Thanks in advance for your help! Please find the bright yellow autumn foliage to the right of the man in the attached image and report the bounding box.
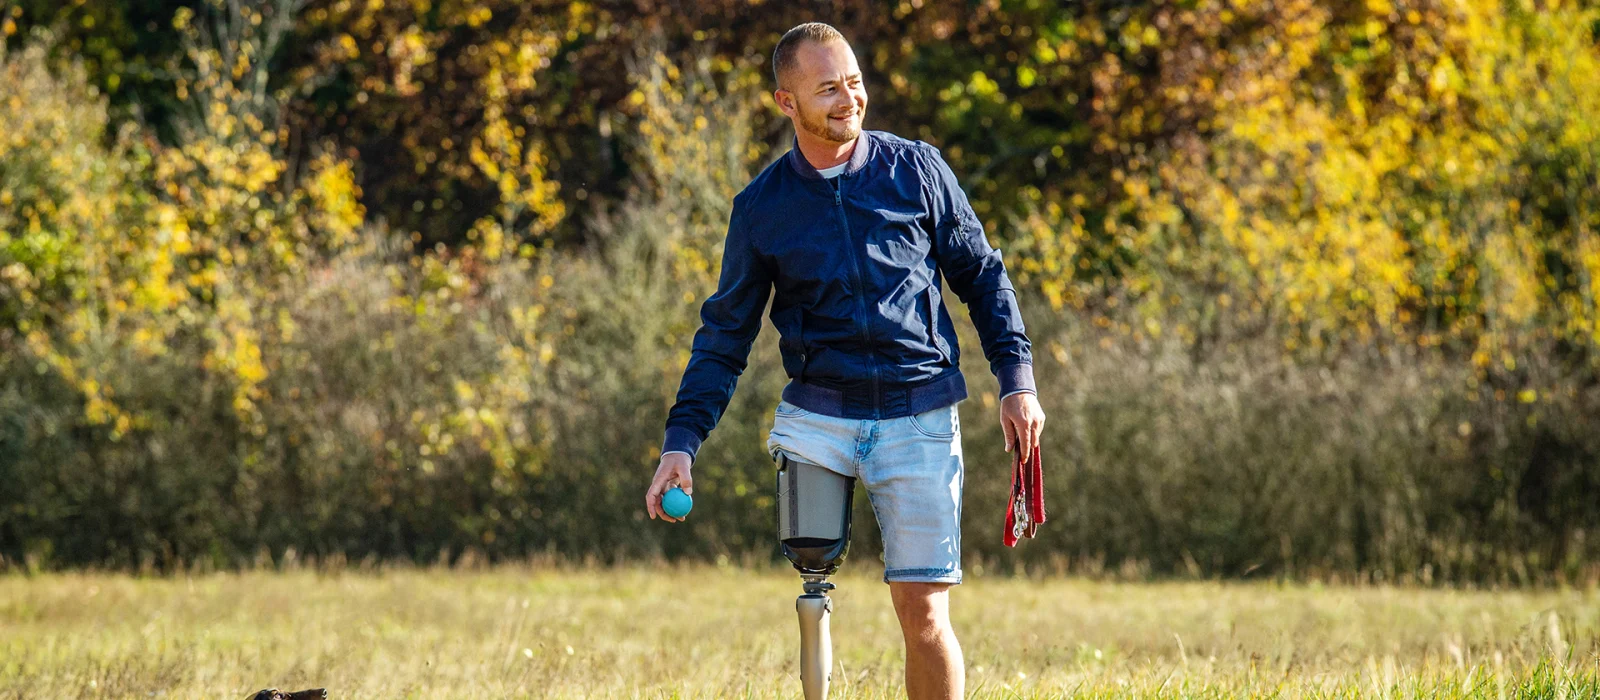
[1014,0,1600,368]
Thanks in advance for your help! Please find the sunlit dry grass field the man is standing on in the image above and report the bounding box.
[0,561,1600,698]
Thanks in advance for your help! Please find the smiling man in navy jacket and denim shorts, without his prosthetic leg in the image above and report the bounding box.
[645,22,1045,698]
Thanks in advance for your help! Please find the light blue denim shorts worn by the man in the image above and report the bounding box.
[766,401,965,583]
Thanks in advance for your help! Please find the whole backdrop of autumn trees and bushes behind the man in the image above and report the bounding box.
[0,0,1600,583]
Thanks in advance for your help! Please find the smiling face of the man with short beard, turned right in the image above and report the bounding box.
[773,42,867,144]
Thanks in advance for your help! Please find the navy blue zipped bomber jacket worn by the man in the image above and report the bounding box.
[661,131,1034,460]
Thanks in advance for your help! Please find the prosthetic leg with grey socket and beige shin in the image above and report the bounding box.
[778,452,856,700]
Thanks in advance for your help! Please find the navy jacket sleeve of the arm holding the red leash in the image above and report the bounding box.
[920,144,1038,398]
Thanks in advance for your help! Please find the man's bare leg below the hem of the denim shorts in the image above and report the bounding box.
[890,582,966,700]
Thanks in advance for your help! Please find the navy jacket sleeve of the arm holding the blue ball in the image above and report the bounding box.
[661,203,773,462]
